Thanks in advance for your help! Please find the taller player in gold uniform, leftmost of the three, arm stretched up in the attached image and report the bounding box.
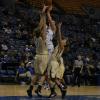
[27,6,48,97]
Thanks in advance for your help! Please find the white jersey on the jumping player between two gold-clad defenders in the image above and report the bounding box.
[46,28,54,55]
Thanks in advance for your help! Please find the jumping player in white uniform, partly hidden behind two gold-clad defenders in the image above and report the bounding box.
[34,5,56,94]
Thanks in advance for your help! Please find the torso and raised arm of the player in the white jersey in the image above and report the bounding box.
[46,6,56,56]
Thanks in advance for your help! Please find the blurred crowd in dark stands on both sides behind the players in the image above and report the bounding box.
[0,1,100,86]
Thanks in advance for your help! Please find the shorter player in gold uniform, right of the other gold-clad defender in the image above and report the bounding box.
[48,23,67,98]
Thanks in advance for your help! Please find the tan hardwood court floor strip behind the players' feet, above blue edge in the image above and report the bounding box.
[0,85,100,96]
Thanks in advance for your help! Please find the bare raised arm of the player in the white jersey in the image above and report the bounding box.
[47,6,56,33]
